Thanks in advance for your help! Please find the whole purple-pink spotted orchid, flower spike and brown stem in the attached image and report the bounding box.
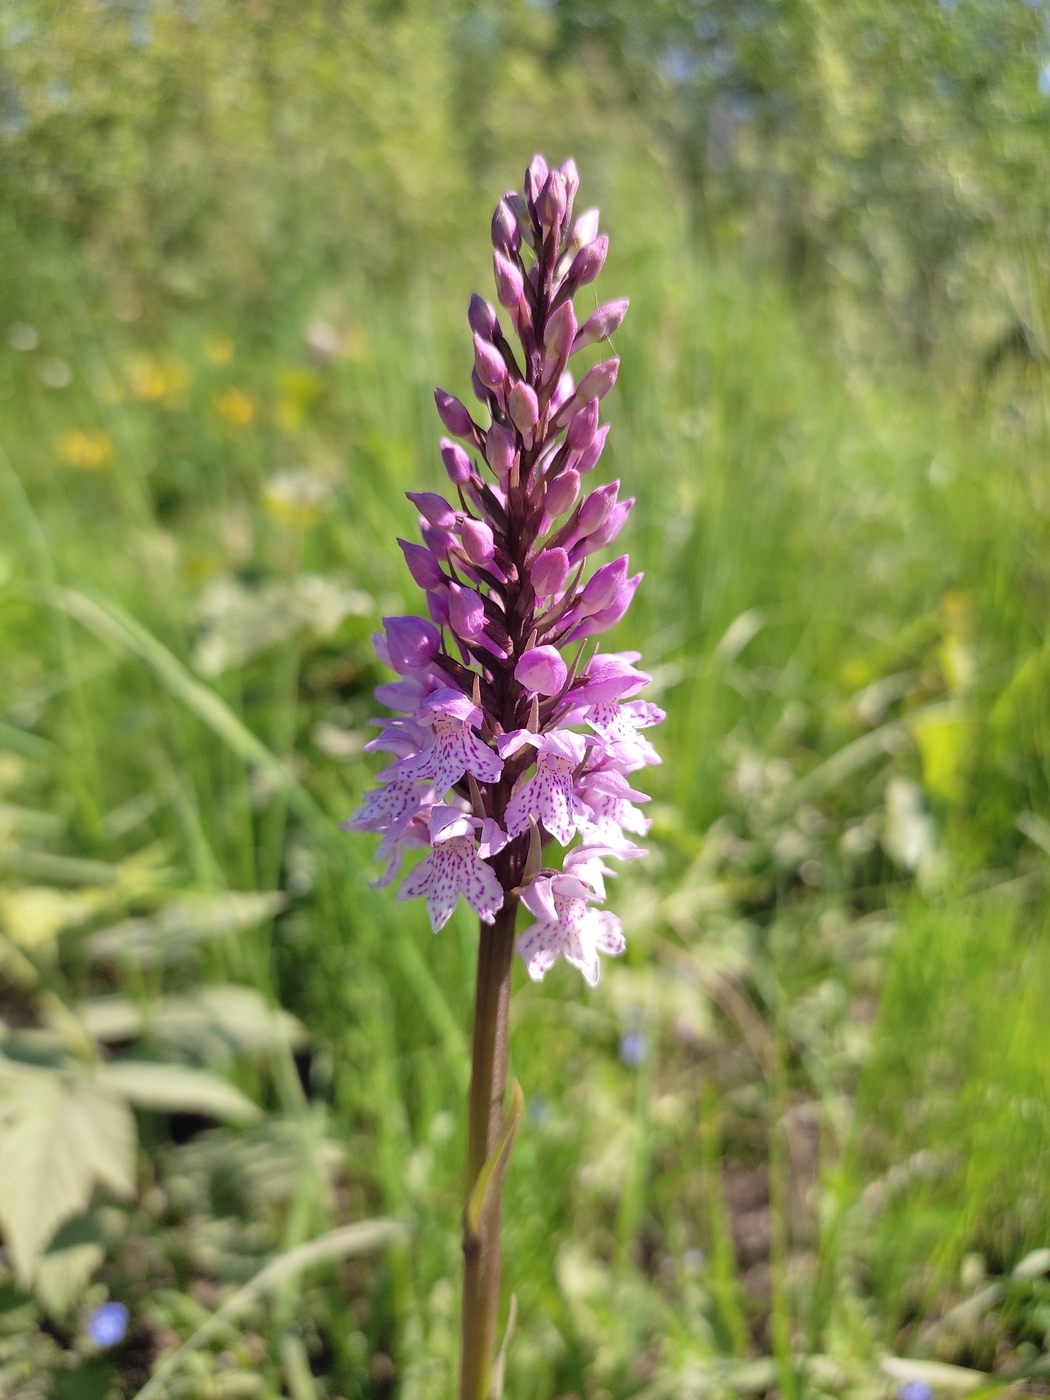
[344,155,662,1400]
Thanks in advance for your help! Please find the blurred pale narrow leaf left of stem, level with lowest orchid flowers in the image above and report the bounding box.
[87,893,284,967]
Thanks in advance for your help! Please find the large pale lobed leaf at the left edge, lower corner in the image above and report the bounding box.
[0,1063,136,1287]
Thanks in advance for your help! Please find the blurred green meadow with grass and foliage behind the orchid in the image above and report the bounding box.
[0,0,1050,1400]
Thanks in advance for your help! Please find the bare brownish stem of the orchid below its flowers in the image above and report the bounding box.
[459,896,518,1400]
